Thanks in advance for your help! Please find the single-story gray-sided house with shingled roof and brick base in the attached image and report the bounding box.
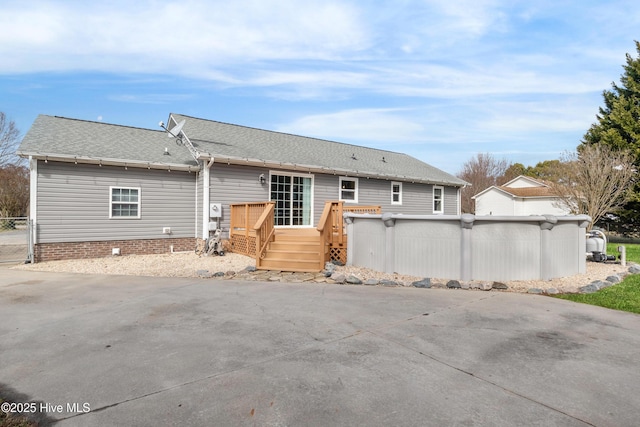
[18,114,466,261]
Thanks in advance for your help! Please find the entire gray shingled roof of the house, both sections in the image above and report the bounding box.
[18,114,466,186]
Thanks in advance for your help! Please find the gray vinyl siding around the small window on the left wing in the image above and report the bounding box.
[36,161,196,243]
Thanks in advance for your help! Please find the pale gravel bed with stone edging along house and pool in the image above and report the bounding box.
[12,252,629,294]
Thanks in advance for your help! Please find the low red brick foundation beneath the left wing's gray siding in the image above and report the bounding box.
[34,237,196,262]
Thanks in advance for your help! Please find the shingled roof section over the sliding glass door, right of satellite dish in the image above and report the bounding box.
[172,114,466,186]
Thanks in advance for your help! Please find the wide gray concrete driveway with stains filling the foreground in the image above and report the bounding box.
[0,267,640,426]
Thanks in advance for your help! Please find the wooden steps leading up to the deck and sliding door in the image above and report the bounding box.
[256,228,324,272]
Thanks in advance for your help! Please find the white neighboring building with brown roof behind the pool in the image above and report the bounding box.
[472,175,570,216]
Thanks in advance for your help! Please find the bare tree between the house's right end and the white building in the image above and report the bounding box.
[457,153,510,213]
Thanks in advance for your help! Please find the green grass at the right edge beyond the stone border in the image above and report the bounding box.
[554,243,640,314]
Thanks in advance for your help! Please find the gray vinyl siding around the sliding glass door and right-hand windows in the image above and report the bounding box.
[208,163,458,234]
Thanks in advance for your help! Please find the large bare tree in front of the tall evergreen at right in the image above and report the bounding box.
[552,144,637,231]
